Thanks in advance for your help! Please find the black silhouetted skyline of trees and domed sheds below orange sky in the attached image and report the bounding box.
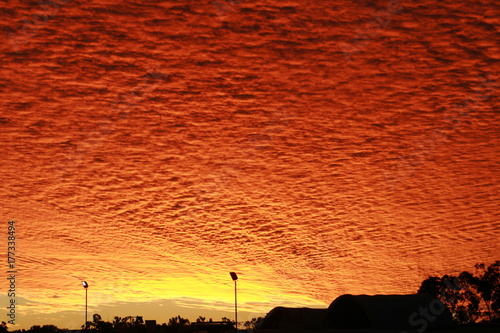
[5,261,500,333]
